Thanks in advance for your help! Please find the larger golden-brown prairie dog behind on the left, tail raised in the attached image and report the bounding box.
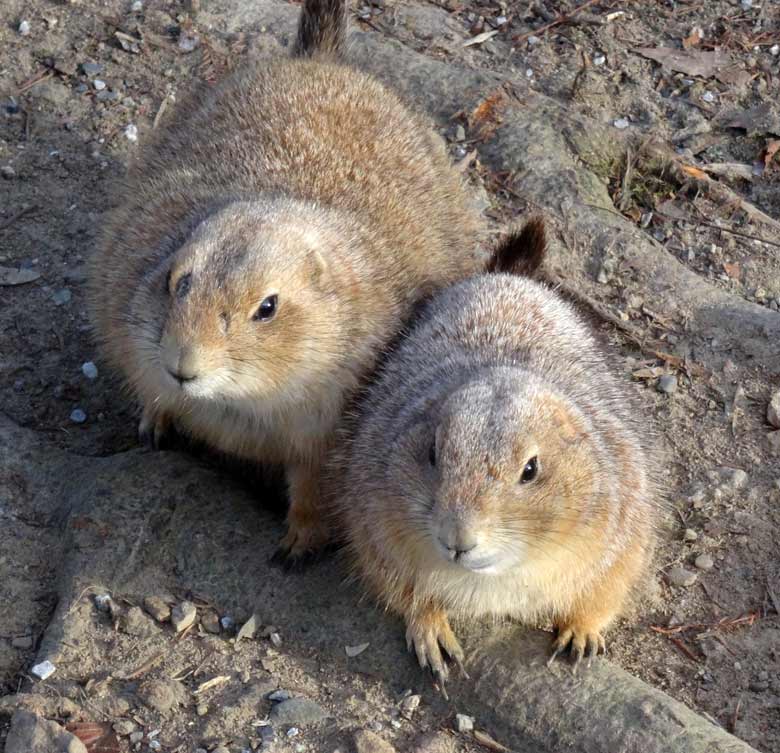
[90,0,481,555]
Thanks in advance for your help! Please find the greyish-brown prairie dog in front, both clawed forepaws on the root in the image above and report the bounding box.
[331,221,660,681]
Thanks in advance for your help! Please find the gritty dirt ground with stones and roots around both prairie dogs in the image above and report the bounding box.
[0,0,780,753]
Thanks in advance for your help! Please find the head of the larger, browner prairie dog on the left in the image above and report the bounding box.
[132,202,354,404]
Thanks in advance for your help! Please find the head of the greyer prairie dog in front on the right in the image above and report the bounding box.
[401,370,601,576]
